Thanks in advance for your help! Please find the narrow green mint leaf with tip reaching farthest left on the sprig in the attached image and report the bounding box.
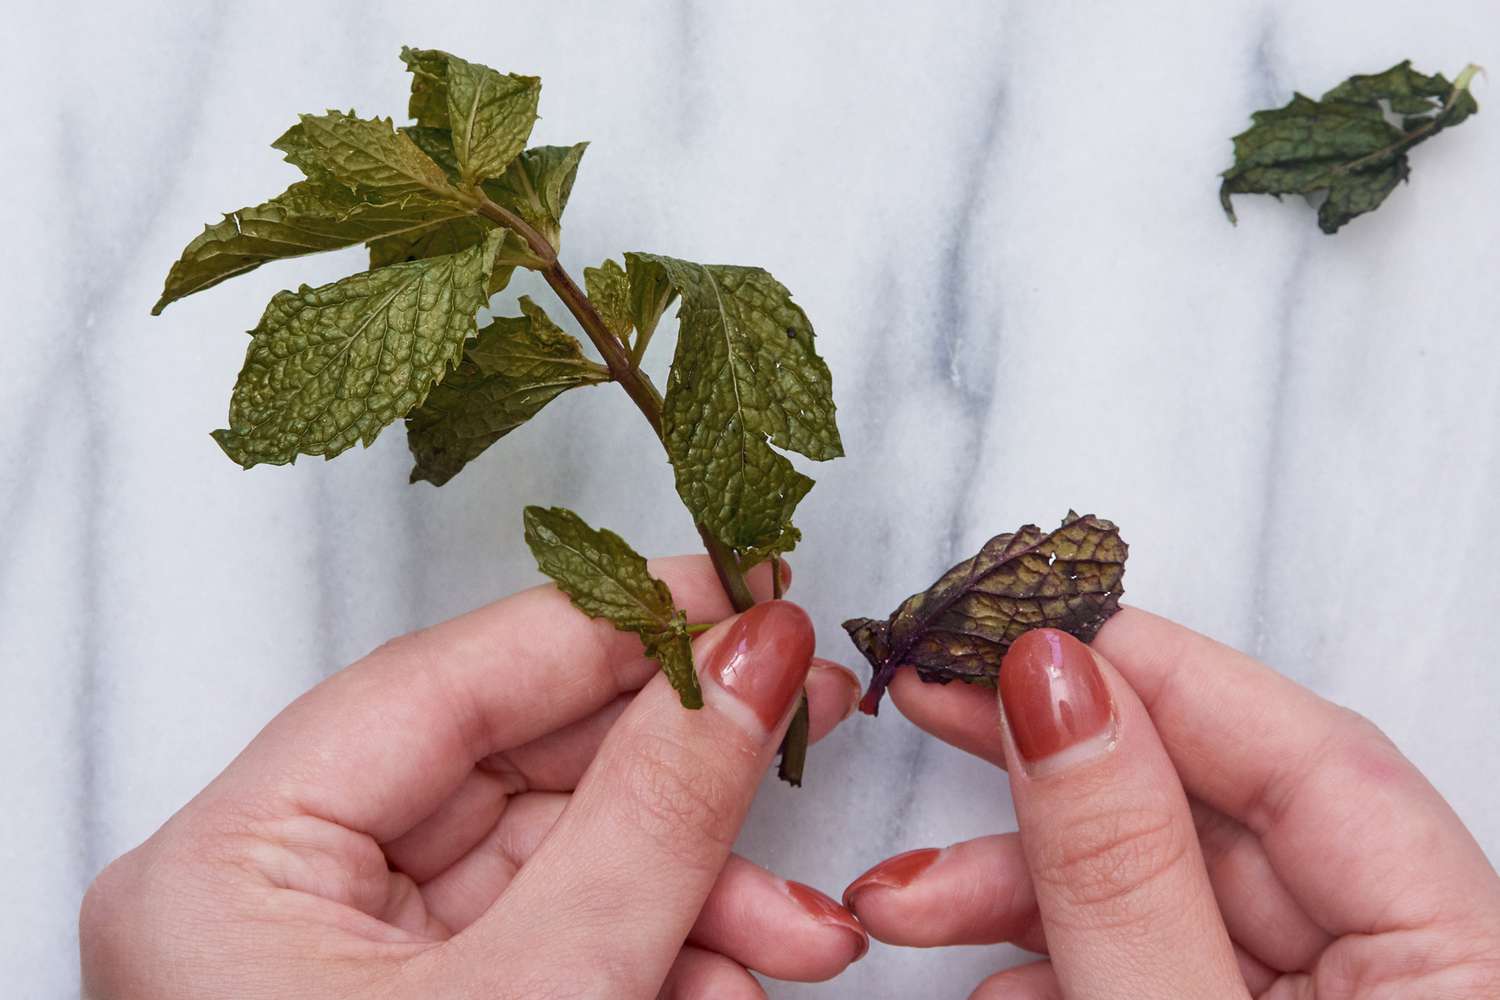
[152,173,467,315]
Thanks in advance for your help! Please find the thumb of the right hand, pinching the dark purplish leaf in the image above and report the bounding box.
[999,628,1248,1000]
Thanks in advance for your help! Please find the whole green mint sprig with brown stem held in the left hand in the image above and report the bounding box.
[153,48,843,784]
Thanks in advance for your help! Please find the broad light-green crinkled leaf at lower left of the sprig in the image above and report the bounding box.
[213,237,500,468]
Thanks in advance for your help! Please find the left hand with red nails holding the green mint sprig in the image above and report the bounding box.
[80,558,867,1000]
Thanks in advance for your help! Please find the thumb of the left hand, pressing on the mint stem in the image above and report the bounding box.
[465,601,815,997]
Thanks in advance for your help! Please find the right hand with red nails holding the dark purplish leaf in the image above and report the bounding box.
[845,609,1500,1000]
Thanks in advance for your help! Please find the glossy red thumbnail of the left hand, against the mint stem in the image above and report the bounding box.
[704,601,815,732]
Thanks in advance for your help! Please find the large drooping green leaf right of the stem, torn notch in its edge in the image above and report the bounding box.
[626,253,843,552]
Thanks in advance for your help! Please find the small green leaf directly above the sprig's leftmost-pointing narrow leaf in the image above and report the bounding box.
[275,111,459,208]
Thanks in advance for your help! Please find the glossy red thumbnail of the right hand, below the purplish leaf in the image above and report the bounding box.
[1001,628,1115,775]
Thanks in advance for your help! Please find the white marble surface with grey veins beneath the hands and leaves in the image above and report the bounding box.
[0,0,1500,997]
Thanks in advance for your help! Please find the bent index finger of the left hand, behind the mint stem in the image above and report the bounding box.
[201,556,771,841]
